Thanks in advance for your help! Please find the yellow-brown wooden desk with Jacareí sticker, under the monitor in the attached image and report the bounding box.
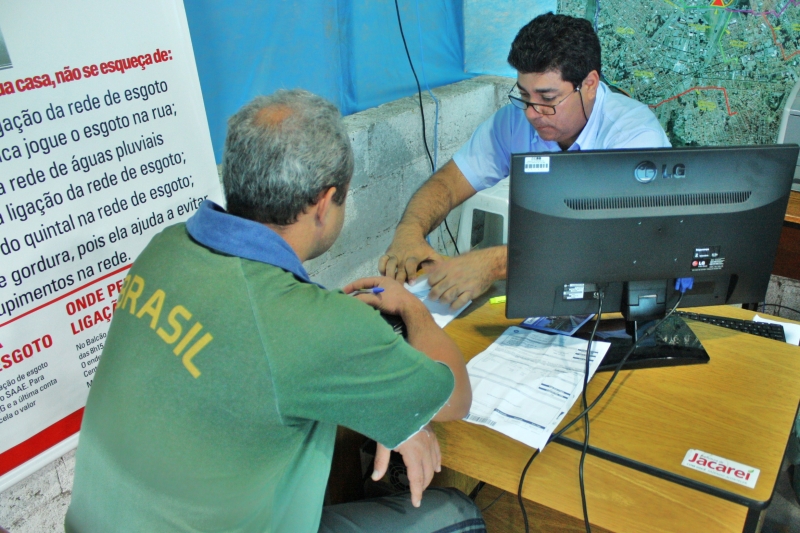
[436,303,800,532]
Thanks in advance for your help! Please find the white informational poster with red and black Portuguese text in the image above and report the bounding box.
[0,0,222,490]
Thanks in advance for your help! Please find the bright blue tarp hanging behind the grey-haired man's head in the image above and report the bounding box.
[185,0,471,161]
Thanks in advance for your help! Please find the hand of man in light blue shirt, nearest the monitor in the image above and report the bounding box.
[425,246,506,309]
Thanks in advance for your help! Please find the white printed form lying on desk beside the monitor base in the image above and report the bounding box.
[464,327,610,450]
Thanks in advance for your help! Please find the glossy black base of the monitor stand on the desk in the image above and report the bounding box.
[575,315,709,372]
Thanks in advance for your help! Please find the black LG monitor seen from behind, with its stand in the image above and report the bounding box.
[506,145,800,367]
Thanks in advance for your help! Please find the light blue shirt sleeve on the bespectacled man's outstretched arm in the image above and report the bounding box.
[453,105,522,191]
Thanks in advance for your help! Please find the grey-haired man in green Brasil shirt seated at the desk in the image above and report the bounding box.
[66,90,484,533]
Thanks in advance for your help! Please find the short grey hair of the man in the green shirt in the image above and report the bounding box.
[222,89,353,226]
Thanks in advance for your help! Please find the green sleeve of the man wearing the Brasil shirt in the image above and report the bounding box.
[270,285,455,448]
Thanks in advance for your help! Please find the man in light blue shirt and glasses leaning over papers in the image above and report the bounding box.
[378,13,670,309]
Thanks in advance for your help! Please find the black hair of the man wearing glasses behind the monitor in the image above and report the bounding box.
[508,13,600,87]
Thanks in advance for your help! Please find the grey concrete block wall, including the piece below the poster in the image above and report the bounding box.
[0,76,513,533]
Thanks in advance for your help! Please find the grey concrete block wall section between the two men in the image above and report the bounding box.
[306,76,514,288]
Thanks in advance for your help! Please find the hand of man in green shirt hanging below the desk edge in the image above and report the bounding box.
[372,424,442,507]
